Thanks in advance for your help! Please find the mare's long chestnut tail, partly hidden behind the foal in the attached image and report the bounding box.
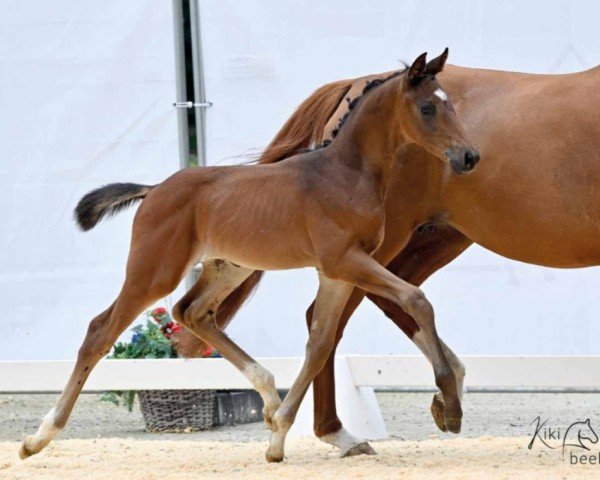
[176,80,355,357]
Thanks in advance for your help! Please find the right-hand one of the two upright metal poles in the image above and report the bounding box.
[190,0,210,167]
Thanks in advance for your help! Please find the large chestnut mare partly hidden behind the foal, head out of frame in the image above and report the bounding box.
[180,59,600,455]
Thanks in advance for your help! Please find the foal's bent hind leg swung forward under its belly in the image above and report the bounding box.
[173,260,281,428]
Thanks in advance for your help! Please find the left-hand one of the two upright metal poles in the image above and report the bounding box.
[173,0,190,168]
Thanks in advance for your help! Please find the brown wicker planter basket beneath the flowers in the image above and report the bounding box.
[138,390,216,432]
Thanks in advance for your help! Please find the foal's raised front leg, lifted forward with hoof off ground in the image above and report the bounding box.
[326,250,462,433]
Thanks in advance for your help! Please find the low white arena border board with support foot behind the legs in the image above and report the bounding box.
[0,355,600,439]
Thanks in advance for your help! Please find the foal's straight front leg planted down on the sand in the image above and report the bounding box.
[266,272,354,462]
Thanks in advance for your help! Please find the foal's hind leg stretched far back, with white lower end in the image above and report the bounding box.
[19,228,189,459]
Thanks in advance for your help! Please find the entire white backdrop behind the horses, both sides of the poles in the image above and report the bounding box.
[0,0,600,360]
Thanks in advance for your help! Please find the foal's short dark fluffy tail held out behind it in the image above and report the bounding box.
[73,183,154,232]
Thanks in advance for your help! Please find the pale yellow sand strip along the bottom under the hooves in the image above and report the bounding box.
[0,437,600,480]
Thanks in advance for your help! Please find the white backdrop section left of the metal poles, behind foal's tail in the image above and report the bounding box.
[0,0,179,360]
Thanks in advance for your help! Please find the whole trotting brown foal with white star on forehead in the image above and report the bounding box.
[20,49,479,461]
